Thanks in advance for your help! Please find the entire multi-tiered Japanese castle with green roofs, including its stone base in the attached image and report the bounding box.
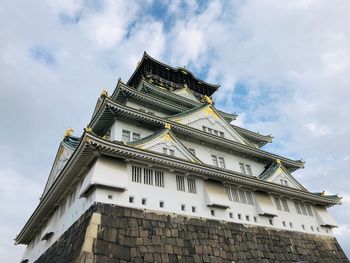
[15,53,348,263]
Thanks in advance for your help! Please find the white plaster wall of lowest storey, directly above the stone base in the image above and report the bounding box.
[23,158,332,262]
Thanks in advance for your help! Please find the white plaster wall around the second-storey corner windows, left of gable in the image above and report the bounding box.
[110,120,156,141]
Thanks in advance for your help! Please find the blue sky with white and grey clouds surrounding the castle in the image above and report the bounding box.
[0,0,350,262]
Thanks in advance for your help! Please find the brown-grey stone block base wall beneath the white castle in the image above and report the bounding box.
[37,204,349,263]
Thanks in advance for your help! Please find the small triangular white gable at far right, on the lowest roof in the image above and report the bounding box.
[259,159,307,191]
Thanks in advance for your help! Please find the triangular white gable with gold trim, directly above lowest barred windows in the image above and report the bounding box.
[128,124,202,163]
